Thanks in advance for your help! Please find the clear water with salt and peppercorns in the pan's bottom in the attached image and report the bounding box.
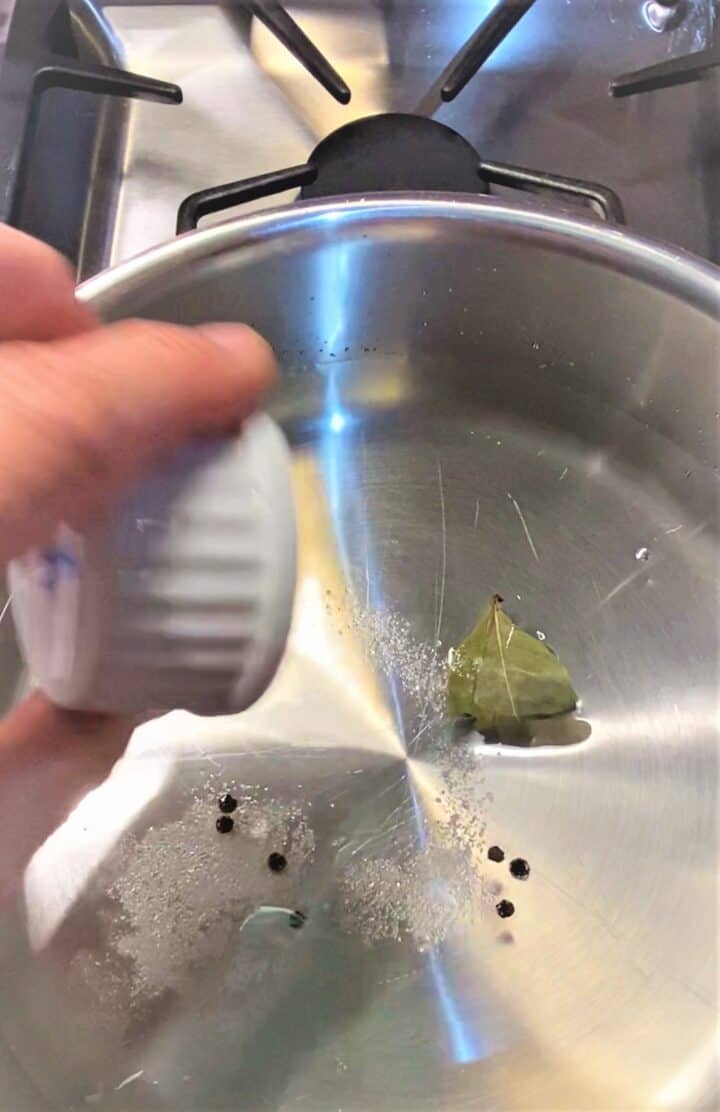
[2,358,717,1112]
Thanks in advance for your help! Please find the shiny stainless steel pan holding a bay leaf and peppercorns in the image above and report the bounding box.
[0,196,720,1112]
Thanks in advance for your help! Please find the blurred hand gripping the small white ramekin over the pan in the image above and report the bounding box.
[0,226,274,907]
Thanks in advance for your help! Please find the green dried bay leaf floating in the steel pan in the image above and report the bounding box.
[447,595,578,733]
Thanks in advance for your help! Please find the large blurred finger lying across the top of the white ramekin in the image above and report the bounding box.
[0,320,275,563]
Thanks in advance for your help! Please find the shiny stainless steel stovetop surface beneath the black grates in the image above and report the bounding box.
[0,0,720,277]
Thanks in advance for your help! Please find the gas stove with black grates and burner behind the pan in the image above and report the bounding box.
[0,0,720,277]
